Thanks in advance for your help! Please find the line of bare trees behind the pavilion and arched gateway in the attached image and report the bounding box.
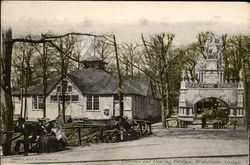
[1,30,250,155]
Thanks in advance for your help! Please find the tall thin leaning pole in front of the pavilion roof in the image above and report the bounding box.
[113,35,123,117]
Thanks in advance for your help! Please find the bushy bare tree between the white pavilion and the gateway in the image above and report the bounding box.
[141,33,178,127]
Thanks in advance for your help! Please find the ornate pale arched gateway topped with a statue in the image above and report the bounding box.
[178,33,244,121]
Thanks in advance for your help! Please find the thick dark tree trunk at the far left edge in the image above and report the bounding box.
[1,29,13,155]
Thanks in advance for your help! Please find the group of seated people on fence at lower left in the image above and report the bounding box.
[14,118,68,156]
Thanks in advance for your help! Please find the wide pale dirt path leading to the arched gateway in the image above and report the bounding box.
[2,124,249,165]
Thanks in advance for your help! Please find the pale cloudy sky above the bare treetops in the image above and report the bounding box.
[1,1,250,45]
